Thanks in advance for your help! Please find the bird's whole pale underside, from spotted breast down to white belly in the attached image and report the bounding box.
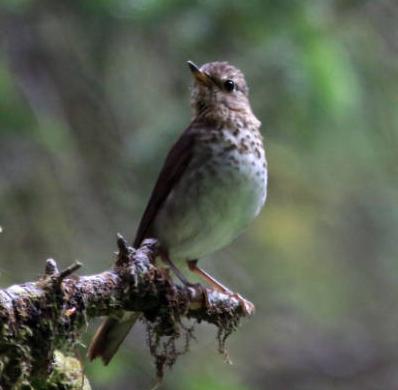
[156,123,267,259]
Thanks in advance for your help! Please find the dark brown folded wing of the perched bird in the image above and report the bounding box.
[133,128,195,248]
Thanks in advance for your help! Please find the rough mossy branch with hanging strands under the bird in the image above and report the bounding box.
[0,236,250,389]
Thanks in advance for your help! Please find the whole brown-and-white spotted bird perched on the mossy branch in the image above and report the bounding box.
[88,61,268,365]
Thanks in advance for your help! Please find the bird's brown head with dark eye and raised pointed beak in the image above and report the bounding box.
[188,61,251,117]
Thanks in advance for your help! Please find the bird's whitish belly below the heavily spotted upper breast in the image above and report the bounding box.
[155,154,267,259]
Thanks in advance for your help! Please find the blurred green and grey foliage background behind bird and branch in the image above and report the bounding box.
[0,0,398,390]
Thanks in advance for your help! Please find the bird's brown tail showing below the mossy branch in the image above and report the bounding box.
[87,312,140,365]
